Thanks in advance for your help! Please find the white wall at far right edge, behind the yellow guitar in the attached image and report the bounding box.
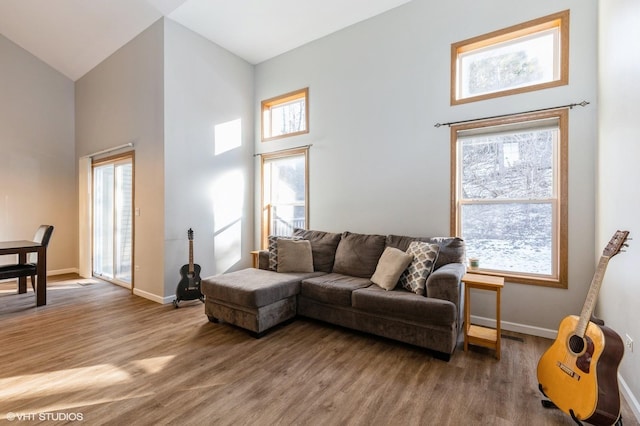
[596,0,640,419]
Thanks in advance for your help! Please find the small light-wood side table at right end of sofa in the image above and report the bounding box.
[462,274,504,359]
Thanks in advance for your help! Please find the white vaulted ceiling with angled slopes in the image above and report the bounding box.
[0,0,410,81]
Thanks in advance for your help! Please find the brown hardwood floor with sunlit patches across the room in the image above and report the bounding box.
[0,277,638,426]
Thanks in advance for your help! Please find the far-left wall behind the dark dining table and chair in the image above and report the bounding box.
[0,35,78,273]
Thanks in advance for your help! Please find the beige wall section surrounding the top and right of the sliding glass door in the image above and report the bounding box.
[74,21,164,301]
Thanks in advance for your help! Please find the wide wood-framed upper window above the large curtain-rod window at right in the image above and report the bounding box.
[451,10,569,105]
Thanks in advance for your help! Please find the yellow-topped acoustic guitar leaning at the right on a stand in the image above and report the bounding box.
[538,231,629,425]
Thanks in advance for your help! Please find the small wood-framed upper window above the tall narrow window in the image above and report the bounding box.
[262,88,309,142]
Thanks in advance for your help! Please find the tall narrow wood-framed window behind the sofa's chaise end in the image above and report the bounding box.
[261,148,309,247]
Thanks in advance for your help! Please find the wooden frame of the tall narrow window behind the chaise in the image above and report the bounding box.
[260,146,309,249]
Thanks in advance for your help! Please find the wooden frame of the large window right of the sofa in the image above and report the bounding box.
[450,108,569,288]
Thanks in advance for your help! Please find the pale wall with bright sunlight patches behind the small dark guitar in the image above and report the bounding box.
[164,19,254,300]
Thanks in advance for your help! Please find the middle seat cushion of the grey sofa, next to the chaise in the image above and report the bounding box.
[300,273,371,306]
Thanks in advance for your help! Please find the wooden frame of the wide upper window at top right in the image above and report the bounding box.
[451,10,570,105]
